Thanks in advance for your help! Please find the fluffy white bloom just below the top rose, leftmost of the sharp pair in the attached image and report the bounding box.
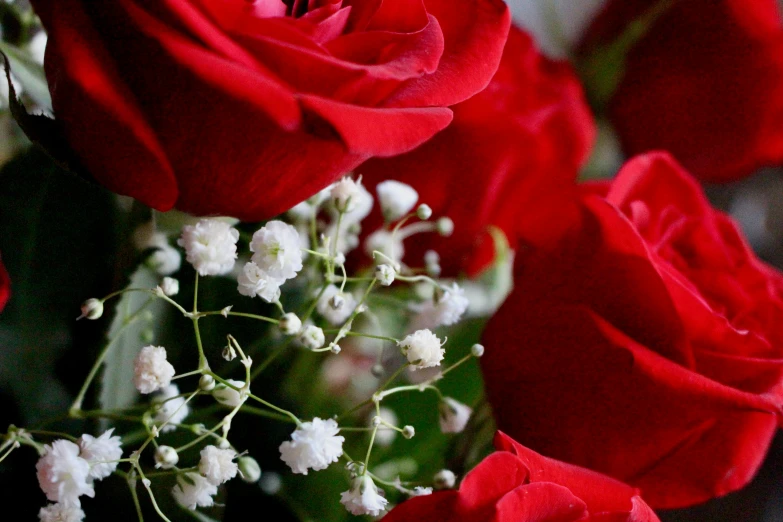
[177,219,239,276]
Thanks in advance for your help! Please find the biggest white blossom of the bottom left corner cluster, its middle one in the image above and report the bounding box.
[35,439,95,508]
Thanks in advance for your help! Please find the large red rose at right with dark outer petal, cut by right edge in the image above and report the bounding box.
[481,153,783,508]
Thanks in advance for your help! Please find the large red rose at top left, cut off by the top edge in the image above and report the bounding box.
[32,0,510,220]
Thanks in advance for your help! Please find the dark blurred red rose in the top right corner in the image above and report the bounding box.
[582,0,783,181]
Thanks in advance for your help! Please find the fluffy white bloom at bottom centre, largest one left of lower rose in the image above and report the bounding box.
[280,417,345,475]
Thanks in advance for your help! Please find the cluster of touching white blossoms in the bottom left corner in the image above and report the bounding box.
[35,430,122,522]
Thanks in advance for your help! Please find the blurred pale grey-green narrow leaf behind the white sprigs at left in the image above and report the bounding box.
[98,266,169,416]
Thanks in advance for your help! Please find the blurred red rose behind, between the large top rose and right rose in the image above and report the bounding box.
[356,23,595,275]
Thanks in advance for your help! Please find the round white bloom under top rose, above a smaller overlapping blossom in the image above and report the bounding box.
[250,221,302,279]
